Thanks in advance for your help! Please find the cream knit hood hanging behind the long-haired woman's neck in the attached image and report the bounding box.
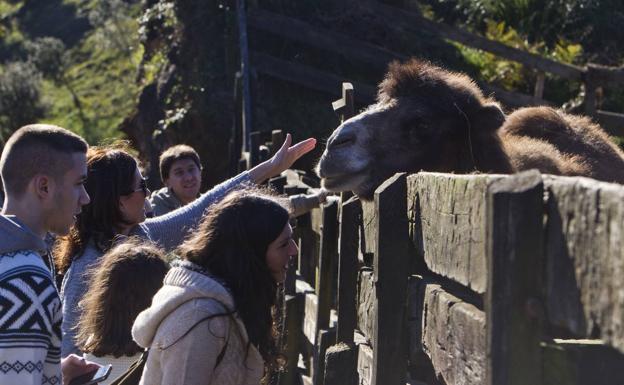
[132,261,239,347]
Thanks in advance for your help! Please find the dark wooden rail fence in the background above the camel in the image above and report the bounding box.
[237,0,624,138]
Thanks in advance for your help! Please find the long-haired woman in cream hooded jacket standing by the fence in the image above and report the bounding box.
[132,189,297,385]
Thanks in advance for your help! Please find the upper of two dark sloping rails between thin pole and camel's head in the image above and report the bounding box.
[247,9,406,70]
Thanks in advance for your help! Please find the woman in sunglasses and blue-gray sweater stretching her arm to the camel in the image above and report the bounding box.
[54,134,316,357]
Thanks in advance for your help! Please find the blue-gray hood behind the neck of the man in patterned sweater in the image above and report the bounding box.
[0,215,48,255]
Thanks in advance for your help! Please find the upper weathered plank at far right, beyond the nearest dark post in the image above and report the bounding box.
[545,177,624,352]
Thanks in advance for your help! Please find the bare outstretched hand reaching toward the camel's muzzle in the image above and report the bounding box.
[249,134,316,184]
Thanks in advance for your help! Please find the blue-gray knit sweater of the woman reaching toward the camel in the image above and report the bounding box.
[61,172,250,357]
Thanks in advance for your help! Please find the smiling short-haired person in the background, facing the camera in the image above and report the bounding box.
[149,144,202,216]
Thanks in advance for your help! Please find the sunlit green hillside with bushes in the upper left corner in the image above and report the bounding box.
[0,0,142,143]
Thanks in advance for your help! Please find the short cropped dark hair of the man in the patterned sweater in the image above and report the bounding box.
[0,124,89,197]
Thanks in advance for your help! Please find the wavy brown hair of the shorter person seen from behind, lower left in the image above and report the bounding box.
[76,238,169,357]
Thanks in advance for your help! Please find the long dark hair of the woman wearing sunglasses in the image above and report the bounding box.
[54,144,137,273]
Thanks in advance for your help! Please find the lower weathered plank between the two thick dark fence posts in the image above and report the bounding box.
[408,277,486,385]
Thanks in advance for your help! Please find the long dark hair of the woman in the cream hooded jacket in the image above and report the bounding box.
[179,188,288,372]
